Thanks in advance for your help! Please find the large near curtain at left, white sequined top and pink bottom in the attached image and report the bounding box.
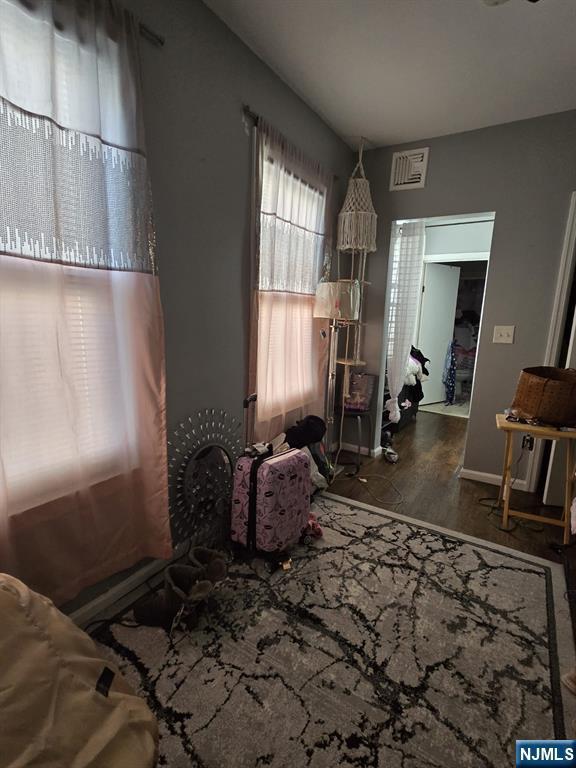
[0,0,172,603]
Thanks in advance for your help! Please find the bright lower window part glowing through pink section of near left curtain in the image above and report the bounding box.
[0,258,134,514]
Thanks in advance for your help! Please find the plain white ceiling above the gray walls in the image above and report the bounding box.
[205,0,576,146]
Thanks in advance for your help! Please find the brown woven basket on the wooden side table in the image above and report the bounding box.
[511,366,576,427]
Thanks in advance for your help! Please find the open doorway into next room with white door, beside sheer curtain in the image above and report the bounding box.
[383,212,495,447]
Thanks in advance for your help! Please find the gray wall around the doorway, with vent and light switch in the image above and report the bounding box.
[365,111,576,477]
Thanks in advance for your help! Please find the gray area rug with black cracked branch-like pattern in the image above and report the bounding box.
[98,496,564,768]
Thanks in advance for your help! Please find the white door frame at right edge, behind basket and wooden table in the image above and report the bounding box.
[526,191,576,491]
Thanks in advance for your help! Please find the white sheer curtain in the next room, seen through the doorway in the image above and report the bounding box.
[384,221,426,422]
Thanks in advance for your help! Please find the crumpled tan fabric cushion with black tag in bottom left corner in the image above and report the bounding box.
[0,574,158,768]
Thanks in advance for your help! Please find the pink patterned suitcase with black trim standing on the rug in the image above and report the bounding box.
[231,448,311,552]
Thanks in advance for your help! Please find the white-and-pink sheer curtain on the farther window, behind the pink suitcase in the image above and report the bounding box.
[252,123,330,440]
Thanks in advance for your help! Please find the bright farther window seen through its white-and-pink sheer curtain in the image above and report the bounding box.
[257,158,326,421]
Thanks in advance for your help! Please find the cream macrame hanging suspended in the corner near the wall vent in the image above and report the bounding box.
[337,142,378,253]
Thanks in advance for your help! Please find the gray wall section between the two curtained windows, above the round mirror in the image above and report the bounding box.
[122,0,352,427]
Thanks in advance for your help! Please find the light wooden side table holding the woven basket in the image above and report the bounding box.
[496,413,576,544]
